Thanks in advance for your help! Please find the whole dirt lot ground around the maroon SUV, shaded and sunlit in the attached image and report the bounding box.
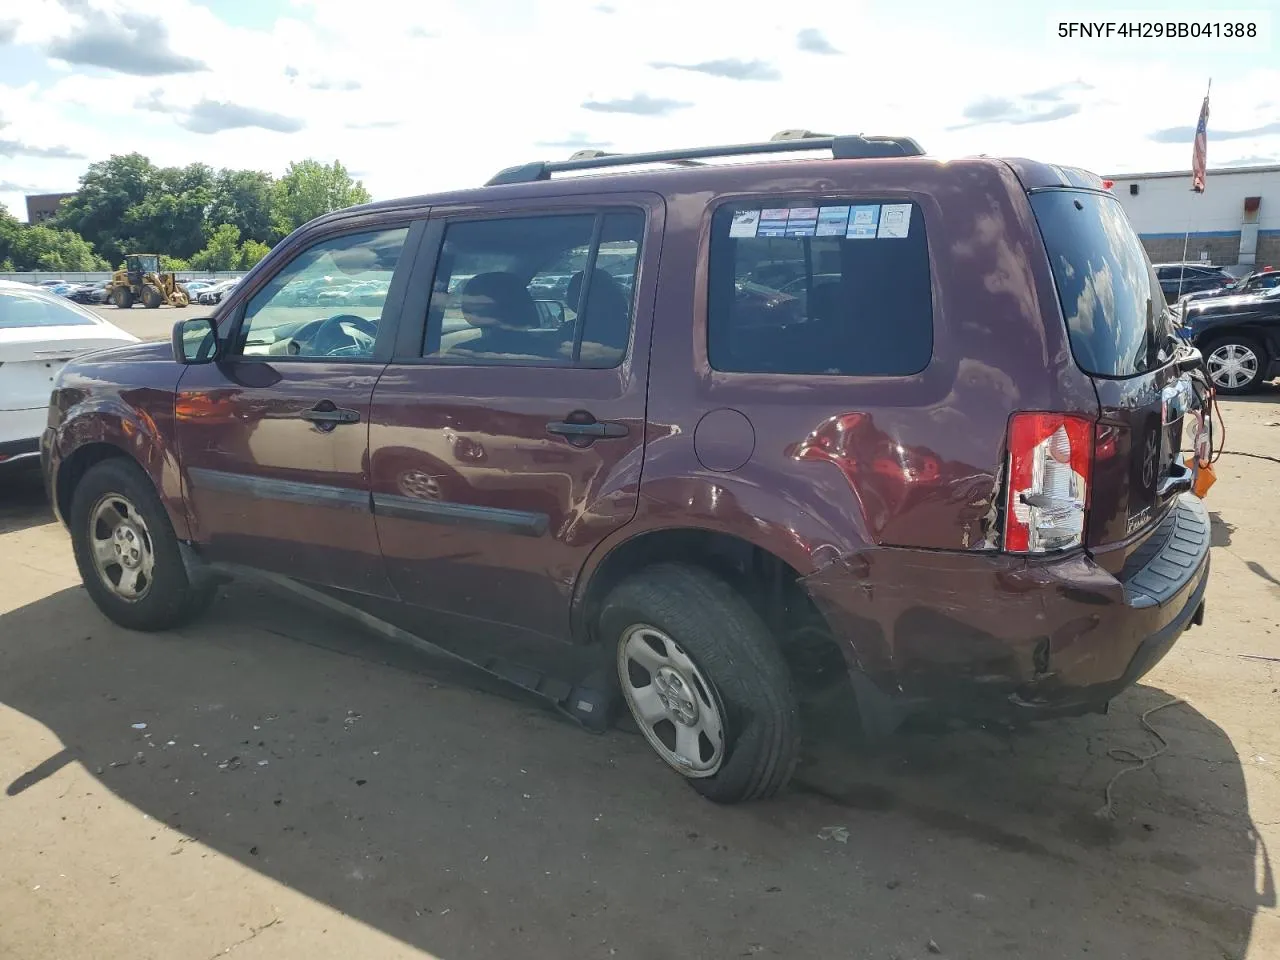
[0,391,1280,960]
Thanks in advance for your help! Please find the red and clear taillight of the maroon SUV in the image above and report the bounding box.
[1005,413,1094,553]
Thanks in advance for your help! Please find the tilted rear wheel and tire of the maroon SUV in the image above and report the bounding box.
[599,563,800,804]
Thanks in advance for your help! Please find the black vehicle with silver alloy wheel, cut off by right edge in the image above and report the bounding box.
[1178,284,1280,394]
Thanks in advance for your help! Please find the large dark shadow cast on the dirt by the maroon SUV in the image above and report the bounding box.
[0,584,1259,960]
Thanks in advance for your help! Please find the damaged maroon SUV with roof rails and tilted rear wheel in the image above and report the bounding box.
[42,129,1210,801]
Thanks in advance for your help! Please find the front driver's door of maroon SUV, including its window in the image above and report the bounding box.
[175,225,421,596]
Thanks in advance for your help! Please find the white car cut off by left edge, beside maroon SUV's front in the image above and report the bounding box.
[0,280,138,468]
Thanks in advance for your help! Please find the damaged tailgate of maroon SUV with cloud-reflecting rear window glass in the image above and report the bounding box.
[1030,188,1202,562]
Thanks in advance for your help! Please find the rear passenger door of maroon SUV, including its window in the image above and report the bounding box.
[370,202,662,639]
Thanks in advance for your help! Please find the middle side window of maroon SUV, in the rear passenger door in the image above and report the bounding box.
[422,211,644,369]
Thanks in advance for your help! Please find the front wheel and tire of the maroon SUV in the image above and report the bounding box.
[69,457,216,631]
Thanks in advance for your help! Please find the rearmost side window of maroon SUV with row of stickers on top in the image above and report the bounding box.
[707,200,933,376]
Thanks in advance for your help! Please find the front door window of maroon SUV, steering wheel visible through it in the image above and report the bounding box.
[238,227,408,360]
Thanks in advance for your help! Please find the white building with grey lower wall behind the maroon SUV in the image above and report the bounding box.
[1106,165,1280,273]
